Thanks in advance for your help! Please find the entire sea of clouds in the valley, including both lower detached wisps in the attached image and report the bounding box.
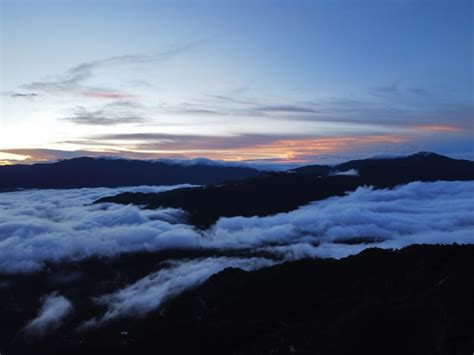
[0,181,474,335]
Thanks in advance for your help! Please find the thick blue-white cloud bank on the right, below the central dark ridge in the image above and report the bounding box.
[207,181,474,257]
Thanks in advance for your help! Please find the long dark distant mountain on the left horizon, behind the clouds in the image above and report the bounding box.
[0,158,261,190]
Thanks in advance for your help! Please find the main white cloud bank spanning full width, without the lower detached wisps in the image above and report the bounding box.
[0,181,474,273]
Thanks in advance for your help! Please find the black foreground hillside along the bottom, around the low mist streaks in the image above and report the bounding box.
[0,245,474,355]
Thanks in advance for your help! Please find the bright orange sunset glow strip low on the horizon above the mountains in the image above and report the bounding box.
[0,134,408,163]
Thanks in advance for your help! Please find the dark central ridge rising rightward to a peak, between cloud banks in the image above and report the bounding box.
[97,153,474,228]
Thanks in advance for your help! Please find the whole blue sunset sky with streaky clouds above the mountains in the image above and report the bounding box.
[0,0,474,164]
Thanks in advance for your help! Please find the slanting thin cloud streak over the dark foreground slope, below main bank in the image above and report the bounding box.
[82,257,275,328]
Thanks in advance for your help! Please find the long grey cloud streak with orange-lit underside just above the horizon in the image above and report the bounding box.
[0,133,413,163]
